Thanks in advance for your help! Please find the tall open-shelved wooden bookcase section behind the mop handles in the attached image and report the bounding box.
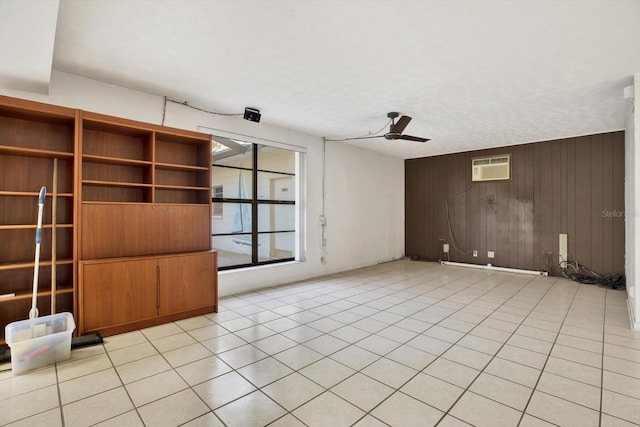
[0,96,76,344]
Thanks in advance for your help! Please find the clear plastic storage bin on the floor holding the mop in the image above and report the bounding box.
[5,313,76,374]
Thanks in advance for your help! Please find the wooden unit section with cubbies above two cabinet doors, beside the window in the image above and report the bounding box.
[79,113,217,334]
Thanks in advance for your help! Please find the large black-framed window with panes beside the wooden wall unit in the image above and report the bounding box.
[211,136,299,270]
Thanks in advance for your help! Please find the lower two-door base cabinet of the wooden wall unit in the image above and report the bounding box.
[78,251,218,335]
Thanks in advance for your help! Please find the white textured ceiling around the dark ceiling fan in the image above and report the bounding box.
[47,0,640,158]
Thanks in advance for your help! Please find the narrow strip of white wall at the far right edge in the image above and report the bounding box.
[625,74,640,330]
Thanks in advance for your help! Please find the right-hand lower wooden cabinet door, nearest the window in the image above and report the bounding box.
[158,252,217,315]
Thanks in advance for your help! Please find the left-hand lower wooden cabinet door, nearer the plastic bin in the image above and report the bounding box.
[80,258,158,330]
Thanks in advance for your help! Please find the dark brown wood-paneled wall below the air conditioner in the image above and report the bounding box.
[405,132,624,275]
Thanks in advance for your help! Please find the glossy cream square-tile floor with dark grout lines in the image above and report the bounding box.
[0,260,640,427]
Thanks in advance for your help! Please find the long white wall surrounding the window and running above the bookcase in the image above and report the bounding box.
[0,71,404,296]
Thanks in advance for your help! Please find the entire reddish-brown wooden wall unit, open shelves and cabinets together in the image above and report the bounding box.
[0,97,217,344]
